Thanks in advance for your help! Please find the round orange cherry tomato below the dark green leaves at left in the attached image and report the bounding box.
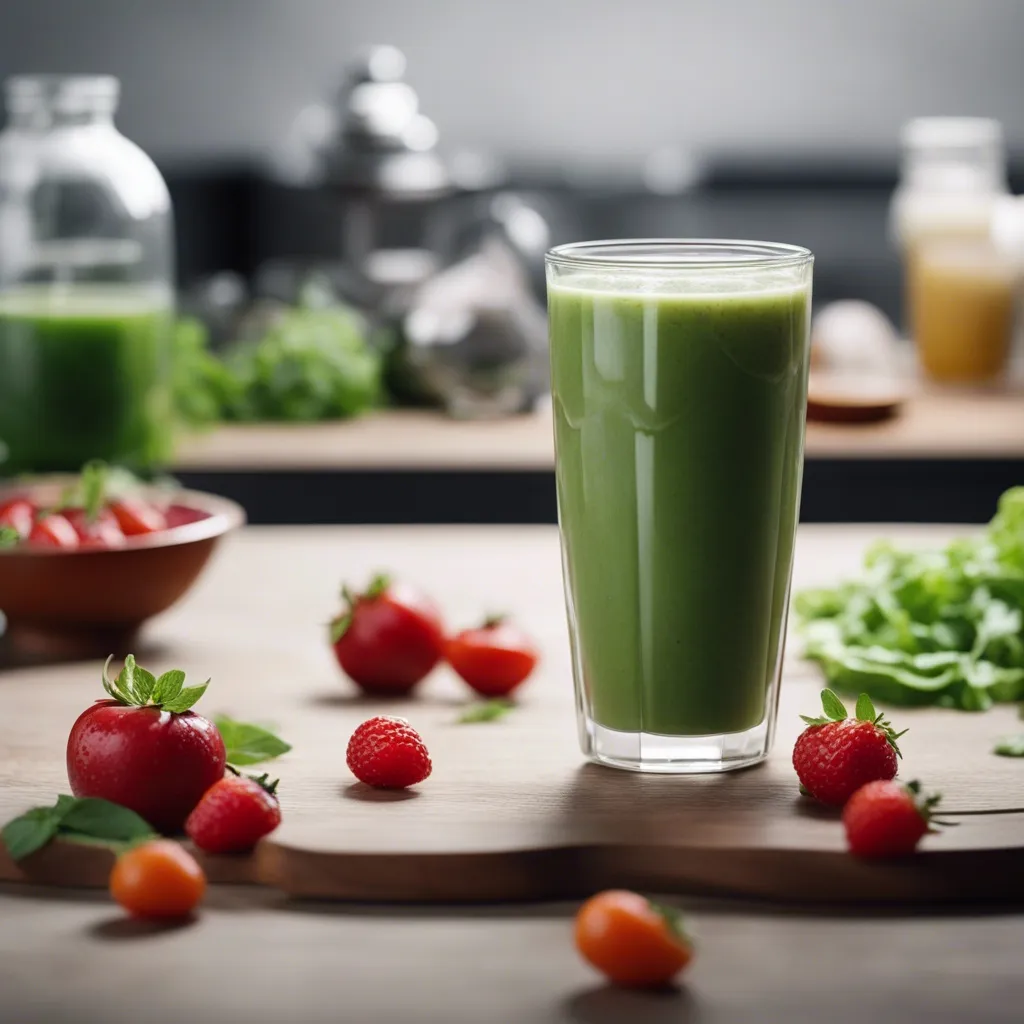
[110,839,206,919]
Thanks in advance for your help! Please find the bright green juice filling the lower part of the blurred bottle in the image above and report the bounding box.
[0,288,171,474]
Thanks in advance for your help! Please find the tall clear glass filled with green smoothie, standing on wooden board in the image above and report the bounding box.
[547,240,813,773]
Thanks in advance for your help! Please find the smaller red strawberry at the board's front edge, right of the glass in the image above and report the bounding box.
[843,780,948,857]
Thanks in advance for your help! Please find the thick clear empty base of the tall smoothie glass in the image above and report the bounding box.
[580,722,771,775]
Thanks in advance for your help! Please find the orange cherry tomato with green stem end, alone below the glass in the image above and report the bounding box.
[575,890,693,988]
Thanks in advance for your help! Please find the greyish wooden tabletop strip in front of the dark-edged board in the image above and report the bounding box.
[0,887,1024,1024]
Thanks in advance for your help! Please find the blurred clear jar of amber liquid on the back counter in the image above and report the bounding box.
[892,118,1015,383]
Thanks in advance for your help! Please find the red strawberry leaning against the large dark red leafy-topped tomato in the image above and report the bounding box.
[185,774,281,853]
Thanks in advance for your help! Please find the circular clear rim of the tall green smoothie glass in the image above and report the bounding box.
[544,239,814,271]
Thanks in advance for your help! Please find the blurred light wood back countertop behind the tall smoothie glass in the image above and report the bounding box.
[175,390,1024,472]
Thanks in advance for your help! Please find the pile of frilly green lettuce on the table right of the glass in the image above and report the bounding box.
[795,487,1024,711]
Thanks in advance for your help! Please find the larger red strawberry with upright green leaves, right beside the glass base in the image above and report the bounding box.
[793,690,906,806]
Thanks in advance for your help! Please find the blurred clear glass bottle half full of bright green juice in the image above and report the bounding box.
[0,76,174,475]
